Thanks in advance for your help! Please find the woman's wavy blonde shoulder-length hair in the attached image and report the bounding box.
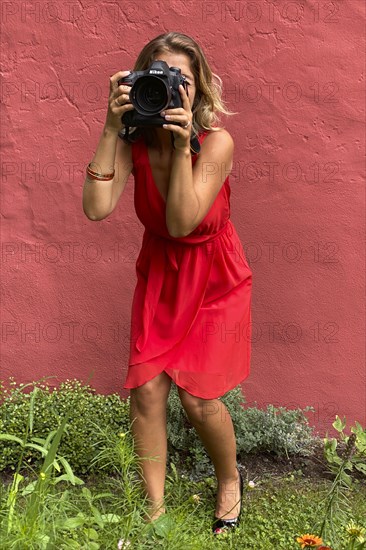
[123,32,236,141]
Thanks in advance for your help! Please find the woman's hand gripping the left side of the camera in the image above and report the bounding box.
[105,71,134,132]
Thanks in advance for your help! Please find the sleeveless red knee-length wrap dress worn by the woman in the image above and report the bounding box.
[124,132,252,399]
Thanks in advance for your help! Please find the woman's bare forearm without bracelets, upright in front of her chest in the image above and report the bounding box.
[166,149,199,237]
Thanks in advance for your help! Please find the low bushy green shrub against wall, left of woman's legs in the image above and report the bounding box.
[0,380,129,474]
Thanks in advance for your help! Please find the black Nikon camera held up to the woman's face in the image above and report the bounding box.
[118,61,188,127]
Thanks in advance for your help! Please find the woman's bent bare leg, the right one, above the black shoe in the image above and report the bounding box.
[178,388,240,519]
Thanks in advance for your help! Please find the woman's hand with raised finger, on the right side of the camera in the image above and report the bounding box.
[161,84,193,151]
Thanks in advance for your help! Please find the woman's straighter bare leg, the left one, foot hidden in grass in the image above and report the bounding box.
[130,372,171,520]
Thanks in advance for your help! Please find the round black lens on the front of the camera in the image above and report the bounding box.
[131,75,170,115]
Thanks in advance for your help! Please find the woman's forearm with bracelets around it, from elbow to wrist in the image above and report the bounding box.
[83,127,119,220]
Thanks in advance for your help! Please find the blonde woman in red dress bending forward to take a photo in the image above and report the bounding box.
[83,32,252,534]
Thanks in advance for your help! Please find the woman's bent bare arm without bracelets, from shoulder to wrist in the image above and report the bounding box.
[166,129,234,237]
